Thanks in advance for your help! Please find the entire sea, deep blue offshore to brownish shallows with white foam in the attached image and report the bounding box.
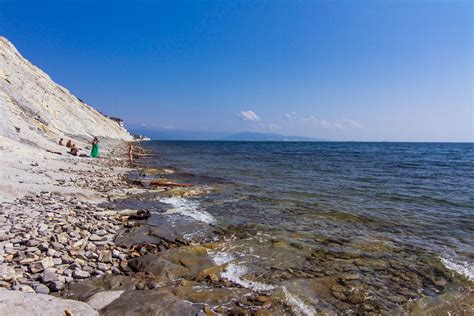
[135,141,474,314]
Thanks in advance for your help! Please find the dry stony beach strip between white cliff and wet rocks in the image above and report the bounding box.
[0,140,147,312]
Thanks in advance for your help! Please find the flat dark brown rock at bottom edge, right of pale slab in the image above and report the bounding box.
[101,289,203,316]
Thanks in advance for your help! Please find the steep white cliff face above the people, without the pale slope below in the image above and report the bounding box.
[0,37,132,148]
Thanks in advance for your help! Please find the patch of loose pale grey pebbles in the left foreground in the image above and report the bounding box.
[0,193,133,294]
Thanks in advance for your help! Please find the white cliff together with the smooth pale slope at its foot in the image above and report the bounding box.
[0,37,133,201]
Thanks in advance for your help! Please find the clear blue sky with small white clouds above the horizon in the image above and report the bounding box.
[0,0,474,142]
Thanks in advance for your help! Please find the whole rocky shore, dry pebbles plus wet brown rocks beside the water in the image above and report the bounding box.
[0,143,288,315]
